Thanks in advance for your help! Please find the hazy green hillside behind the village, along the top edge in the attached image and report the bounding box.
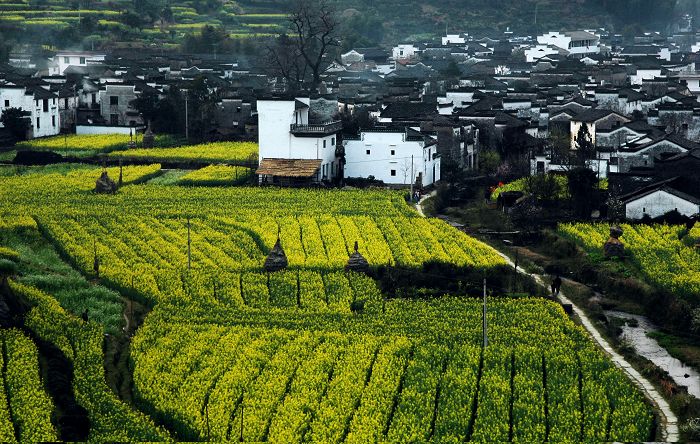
[0,0,697,51]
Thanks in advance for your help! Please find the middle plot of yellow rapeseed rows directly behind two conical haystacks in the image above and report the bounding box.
[35,215,502,306]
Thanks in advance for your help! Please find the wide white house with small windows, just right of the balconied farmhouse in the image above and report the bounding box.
[345,128,440,186]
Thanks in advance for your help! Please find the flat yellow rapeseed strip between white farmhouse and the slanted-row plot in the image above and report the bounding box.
[0,165,418,218]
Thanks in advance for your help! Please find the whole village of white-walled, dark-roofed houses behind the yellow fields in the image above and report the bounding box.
[0,20,700,219]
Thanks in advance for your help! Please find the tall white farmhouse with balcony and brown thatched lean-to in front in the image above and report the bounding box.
[257,97,342,184]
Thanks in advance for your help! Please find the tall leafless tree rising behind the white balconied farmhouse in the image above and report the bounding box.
[289,0,340,89]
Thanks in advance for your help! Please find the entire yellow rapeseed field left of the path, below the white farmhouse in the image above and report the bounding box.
[0,165,654,443]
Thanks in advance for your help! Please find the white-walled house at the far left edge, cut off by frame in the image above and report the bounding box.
[0,84,61,138]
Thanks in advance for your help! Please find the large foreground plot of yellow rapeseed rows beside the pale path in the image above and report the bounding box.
[132,300,652,442]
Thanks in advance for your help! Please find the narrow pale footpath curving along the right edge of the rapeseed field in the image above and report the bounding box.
[416,200,680,442]
